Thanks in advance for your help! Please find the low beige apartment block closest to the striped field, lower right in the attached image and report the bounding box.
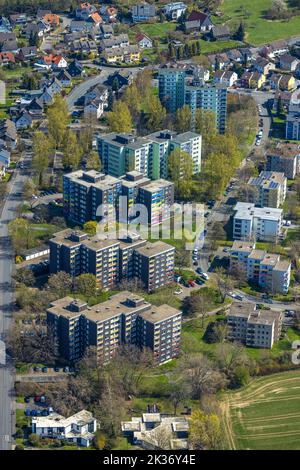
[227,302,282,349]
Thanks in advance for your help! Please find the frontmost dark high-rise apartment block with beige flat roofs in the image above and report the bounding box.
[47,291,181,364]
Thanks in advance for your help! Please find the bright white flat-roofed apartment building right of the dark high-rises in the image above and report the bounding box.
[233,202,282,242]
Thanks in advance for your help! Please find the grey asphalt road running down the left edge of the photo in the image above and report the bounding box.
[0,152,28,450]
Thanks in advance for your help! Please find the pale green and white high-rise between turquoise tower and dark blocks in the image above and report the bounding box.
[97,129,202,180]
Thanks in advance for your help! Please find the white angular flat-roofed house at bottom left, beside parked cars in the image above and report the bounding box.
[31,410,97,447]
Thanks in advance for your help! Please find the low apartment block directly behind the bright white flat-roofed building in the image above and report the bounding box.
[248,171,287,208]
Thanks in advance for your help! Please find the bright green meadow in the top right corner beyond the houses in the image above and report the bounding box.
[217,0,300,45]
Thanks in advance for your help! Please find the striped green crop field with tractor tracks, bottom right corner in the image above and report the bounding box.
[223,370,300,450]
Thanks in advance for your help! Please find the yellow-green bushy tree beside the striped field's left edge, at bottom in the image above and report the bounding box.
[189,410,222,450]
